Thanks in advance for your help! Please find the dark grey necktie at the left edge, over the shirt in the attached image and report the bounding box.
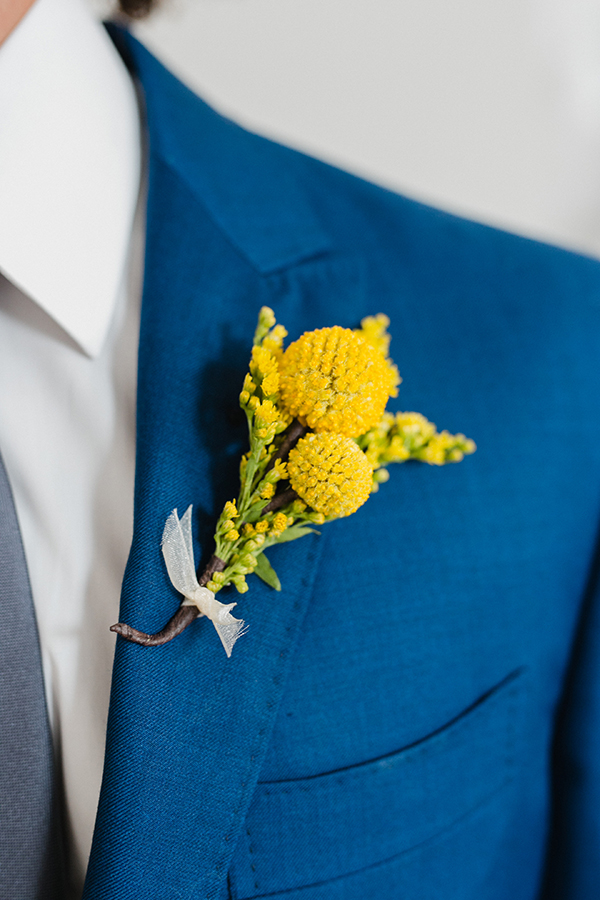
[0,456,62,900]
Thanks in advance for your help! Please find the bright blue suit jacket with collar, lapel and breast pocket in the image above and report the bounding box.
[85,28,600,900]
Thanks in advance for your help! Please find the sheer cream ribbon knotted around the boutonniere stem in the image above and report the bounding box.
[162,506,245,656]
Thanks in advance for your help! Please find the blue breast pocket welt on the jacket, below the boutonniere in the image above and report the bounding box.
[230,669,526,900]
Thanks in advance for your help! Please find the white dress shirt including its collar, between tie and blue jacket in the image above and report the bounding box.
[0,0,143,889]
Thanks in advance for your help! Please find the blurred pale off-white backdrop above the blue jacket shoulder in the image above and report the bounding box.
[126,0,600,257]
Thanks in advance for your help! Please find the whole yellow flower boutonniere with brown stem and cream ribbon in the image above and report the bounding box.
[111,307,475,656]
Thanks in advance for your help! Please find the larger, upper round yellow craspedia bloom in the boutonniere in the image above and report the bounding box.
[279,325,399,437]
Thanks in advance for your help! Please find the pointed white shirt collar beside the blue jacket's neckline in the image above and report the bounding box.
[0,0,141,356]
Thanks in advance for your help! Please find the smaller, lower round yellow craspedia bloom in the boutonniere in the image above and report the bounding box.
[288,433,373,518]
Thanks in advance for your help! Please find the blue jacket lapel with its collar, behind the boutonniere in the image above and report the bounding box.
[84,34,356,900]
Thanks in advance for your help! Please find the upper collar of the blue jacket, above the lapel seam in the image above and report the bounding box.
[108,25,331,274]
